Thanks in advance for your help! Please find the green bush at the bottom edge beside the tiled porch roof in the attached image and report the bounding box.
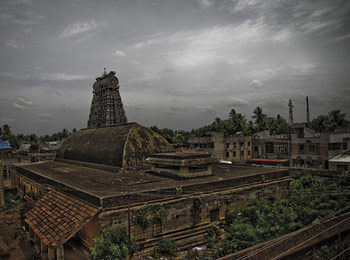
[90,226,137,260]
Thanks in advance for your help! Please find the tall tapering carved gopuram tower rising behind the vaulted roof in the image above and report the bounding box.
[88,69,128,128]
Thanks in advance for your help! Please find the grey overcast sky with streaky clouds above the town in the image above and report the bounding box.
[0,0,350,135]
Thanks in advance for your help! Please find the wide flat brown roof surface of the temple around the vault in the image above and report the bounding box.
[16,161,288,206]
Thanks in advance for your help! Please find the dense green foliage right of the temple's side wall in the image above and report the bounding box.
[213,171,350,259]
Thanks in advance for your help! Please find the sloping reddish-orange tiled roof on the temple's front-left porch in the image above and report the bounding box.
[25,189,98,247]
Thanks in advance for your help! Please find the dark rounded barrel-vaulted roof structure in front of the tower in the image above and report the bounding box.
[57,123,173,168]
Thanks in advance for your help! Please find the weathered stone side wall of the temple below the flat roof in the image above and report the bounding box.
[99,177,291,248]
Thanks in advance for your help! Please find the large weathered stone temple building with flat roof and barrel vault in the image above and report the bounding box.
[15,123,290,260]
